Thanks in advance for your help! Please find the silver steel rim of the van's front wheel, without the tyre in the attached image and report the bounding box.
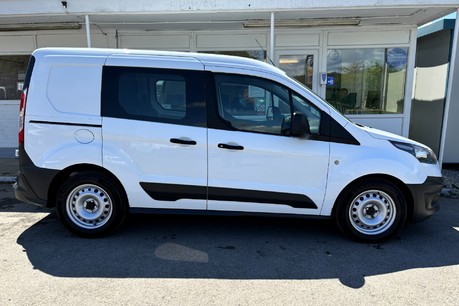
[349,190,397,235]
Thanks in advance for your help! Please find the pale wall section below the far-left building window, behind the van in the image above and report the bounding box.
[0,101,19,148]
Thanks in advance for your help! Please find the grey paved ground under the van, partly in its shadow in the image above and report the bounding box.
[0,184,459,305]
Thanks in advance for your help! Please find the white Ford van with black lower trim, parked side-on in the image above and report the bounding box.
[15,48,442,241]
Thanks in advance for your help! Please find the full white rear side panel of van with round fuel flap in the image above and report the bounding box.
[24,54,106,170]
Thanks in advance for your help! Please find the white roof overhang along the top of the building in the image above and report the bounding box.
[0,0,459,31]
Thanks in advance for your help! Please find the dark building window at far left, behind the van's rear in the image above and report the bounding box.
[0,55,30,100]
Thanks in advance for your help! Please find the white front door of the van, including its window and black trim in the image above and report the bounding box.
[208,74,329,215]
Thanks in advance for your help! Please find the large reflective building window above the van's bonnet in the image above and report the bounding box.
[326,48,407,114]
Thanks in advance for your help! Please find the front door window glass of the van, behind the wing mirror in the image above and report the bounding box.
[215,74,291,135]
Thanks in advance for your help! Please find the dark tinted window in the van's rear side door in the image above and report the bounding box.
[101,66,206,126]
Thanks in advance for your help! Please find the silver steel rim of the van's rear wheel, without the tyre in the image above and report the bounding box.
[66,184,113,229]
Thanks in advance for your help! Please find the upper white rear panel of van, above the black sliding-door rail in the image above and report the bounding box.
[26,55,106,124]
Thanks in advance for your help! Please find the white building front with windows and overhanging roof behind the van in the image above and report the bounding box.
[0,0,459,161]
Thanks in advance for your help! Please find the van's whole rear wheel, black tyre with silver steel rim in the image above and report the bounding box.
[56,171,128,237]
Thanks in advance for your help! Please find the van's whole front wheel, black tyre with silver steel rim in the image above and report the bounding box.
[334,179,407,242]
